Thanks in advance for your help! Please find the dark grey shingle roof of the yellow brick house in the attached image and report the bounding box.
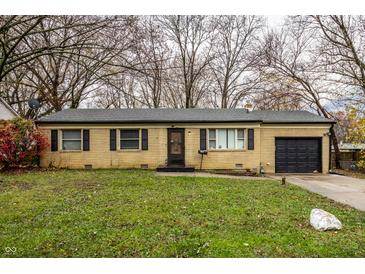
[37,109,333,123]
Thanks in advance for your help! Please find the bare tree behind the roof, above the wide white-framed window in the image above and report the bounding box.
[210,16,264,108]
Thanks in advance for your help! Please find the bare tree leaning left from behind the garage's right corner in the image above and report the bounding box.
[265,18,340,167]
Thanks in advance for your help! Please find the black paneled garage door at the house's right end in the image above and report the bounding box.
[275,137,322,173]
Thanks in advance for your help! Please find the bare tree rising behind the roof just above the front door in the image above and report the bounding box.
[159,15,214,108]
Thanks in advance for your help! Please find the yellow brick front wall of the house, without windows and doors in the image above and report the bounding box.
[39,123,330,173]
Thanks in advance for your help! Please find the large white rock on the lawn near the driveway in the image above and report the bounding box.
[310,208,342,231]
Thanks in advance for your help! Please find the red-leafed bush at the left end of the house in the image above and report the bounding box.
[0,118,48,169]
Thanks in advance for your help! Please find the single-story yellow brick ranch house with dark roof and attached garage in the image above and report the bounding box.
[37,109,334,173]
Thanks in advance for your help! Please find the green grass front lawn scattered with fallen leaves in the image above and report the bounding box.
[0,170,365,257]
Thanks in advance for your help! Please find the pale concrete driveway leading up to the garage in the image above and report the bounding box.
[272,174,365,211]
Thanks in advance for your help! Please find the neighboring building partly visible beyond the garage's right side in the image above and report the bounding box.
[332,143,365,169]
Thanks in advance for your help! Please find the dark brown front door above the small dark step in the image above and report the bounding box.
[167,128,185,166]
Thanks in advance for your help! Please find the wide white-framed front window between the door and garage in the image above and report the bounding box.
[208,128,245,149]
